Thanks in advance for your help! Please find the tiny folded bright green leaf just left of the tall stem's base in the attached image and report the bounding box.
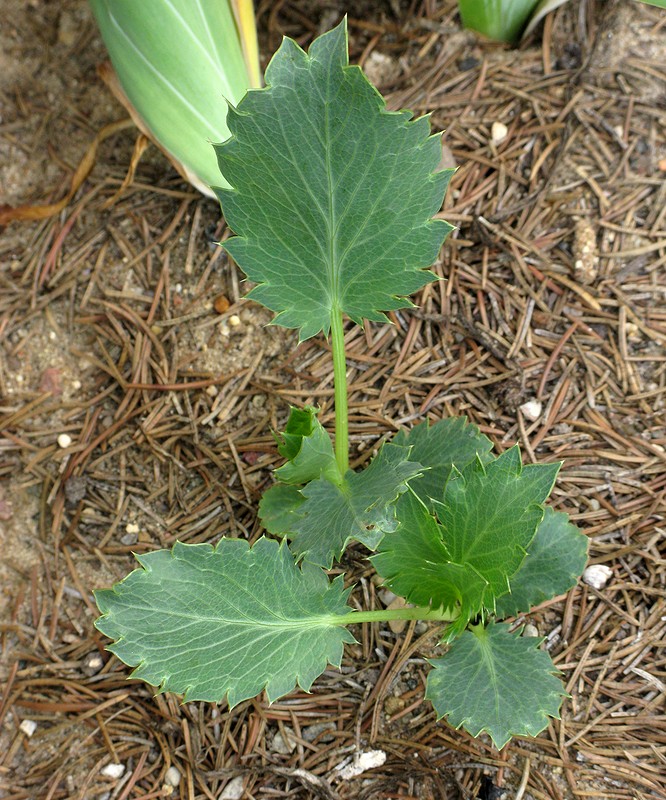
[275,406,341,484]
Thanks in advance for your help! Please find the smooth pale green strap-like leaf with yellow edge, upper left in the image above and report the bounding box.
[90,0,261,196]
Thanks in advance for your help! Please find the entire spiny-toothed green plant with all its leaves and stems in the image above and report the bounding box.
[96,23,586,747]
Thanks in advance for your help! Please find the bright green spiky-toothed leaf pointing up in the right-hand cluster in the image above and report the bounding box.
[433,446,560,610]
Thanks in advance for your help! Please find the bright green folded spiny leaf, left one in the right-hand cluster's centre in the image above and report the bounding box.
[371,490,488,634]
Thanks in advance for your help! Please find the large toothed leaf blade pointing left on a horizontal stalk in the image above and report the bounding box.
[95,539,354,706]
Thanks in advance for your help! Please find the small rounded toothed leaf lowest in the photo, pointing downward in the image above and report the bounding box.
[426,623,566,749]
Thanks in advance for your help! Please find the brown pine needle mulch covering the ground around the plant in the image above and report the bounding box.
[0,0,666,800]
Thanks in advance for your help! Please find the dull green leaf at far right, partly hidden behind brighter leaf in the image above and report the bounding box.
[495,507,587,619]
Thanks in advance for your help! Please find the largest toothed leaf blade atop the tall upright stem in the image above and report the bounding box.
[216,22,452,339]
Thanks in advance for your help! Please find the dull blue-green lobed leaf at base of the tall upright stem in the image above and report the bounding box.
[289,444,421,569]
